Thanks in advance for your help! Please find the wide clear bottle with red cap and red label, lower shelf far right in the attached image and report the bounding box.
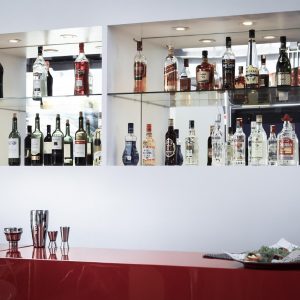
[277,114,298,166]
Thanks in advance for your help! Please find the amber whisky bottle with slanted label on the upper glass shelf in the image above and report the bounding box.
[164,46,178,92]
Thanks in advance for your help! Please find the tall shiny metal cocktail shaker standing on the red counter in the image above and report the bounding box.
[30,210,49,248]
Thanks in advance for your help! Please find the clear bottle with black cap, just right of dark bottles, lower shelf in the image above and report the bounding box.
[185,120,199,165]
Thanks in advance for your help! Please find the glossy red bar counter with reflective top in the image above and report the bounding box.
[0,247,300,300]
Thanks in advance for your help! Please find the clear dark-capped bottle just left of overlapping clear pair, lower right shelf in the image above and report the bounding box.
[233,118,246,166]
